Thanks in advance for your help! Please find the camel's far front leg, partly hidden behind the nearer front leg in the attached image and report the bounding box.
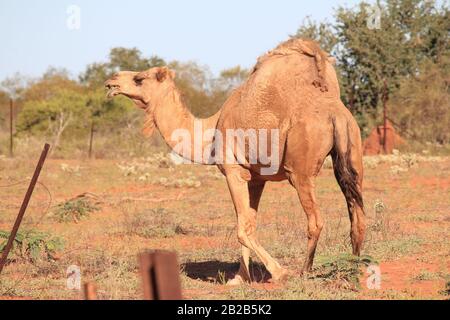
[227,181,265,285]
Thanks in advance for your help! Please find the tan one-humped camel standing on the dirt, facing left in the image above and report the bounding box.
[105,39,366,284]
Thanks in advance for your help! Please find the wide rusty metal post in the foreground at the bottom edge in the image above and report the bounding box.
[139,250,182,300]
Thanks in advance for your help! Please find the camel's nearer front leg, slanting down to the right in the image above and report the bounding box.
[226,170,287,280]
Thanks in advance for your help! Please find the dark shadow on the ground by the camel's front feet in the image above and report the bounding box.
[181,260,271,283]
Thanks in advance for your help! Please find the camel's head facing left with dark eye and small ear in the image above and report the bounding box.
[105,67,174,109]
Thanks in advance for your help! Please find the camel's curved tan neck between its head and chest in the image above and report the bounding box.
[153,85,220,164]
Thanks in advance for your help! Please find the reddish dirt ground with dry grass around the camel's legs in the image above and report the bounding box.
[0,154,450,299]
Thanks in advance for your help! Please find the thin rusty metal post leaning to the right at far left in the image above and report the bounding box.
[0,143,50,273]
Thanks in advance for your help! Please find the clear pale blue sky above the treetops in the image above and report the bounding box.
[0,0,359,81]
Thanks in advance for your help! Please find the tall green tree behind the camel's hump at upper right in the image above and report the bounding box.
[295,0,450,133]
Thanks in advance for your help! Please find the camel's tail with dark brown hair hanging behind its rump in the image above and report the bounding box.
[331,118,364,209]
